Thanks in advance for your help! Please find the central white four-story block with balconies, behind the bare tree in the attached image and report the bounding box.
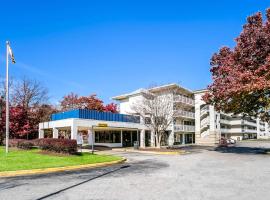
[113,84,195,145]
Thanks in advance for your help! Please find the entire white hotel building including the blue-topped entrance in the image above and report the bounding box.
[39,84,270,147]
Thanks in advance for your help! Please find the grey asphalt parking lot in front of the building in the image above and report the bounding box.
[0,141,270,200]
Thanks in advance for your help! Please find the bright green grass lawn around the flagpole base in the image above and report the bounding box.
[0,146,121,172]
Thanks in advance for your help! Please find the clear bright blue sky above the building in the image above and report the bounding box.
[0,0,270,104]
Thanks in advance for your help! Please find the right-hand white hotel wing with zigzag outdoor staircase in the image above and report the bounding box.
[194,90,270,144]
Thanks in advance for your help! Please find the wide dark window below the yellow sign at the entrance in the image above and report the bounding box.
[95,131,121,143]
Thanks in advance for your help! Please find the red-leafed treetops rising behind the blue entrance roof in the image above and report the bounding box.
[60,93,117,113]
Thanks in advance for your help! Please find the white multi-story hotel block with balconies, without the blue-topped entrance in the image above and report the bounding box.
[113,84,270,145]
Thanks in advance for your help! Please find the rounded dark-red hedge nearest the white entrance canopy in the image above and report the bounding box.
[36,138,77,154]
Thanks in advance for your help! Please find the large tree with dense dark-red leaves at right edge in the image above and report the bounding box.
[203,9,270,121]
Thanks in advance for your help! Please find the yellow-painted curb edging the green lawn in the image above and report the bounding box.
[0,158,127,178]
